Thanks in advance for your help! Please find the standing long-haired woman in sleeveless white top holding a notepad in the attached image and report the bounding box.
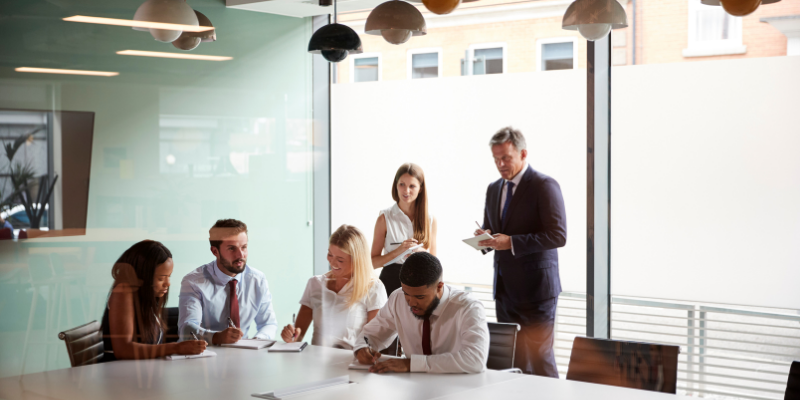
[372,163,436,296]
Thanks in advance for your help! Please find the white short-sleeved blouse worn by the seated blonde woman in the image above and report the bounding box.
[300,274,387,350]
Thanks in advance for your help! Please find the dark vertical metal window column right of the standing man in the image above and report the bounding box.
[586,34,611,339]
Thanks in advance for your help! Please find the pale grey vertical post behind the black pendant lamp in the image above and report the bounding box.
[311,15,331,275]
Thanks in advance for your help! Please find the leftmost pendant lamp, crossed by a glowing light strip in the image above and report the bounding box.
[133,0,200,43]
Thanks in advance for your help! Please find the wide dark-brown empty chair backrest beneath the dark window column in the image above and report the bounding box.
[567,337,680,394]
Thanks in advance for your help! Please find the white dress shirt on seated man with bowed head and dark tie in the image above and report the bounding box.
[355,285,489,374]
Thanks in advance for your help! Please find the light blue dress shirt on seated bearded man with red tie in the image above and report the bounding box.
[178,260,278,344]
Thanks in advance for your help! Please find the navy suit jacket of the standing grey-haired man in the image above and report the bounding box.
[483,166,567,304]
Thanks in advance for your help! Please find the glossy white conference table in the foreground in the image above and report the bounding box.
[0,346,686,400]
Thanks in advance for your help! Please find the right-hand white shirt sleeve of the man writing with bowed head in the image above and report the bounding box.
[410,303,489,374]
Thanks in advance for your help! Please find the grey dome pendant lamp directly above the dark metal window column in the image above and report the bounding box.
[561,0,628,41]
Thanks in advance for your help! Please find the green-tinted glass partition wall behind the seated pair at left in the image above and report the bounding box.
[0,0,313,376]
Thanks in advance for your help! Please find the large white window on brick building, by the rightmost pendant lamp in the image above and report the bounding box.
[683,0,746,57]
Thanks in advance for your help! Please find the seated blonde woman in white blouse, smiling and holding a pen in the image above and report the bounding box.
[281,225,387,350]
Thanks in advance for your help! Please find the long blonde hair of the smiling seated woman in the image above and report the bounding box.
[328,225,375,307]
